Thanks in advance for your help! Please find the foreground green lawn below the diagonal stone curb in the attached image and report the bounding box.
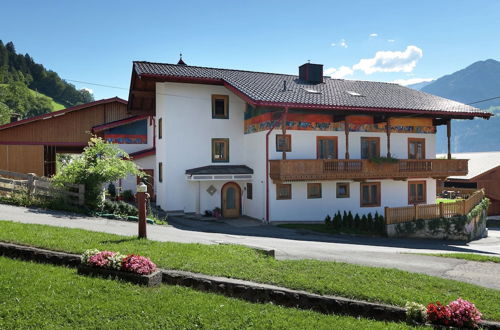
[0,257,414,329]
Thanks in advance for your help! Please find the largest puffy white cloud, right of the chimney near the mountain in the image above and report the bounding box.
[352,46,423,74]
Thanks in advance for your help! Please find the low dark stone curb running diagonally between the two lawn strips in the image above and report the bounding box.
[0,242,500,330]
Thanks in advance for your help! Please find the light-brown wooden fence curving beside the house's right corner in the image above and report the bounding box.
[385,189,485,225]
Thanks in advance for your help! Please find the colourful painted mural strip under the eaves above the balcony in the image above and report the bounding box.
[245,106,436,134]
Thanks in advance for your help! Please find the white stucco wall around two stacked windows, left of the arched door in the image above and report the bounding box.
[156,83,245,212]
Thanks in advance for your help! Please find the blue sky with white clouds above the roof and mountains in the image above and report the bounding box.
[0,0,500,99]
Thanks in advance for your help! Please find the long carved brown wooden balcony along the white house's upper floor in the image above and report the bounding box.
[269,159,468,182]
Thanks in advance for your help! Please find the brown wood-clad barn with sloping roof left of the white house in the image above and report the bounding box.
[0,97,131,176]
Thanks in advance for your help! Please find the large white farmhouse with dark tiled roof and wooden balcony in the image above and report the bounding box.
[128,62,490,222]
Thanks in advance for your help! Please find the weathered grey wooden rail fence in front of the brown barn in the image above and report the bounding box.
[0,170,85,205]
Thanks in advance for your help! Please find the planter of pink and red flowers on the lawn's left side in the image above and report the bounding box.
[78,249,162,286]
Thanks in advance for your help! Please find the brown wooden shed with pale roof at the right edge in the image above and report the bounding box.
[438,151,500,215]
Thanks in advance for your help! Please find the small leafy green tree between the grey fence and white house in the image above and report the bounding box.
[53,136,144,210]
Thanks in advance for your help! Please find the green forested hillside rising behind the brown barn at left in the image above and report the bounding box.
[0,40,93,124]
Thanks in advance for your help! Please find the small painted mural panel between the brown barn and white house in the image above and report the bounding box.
[104,119,148,144]
